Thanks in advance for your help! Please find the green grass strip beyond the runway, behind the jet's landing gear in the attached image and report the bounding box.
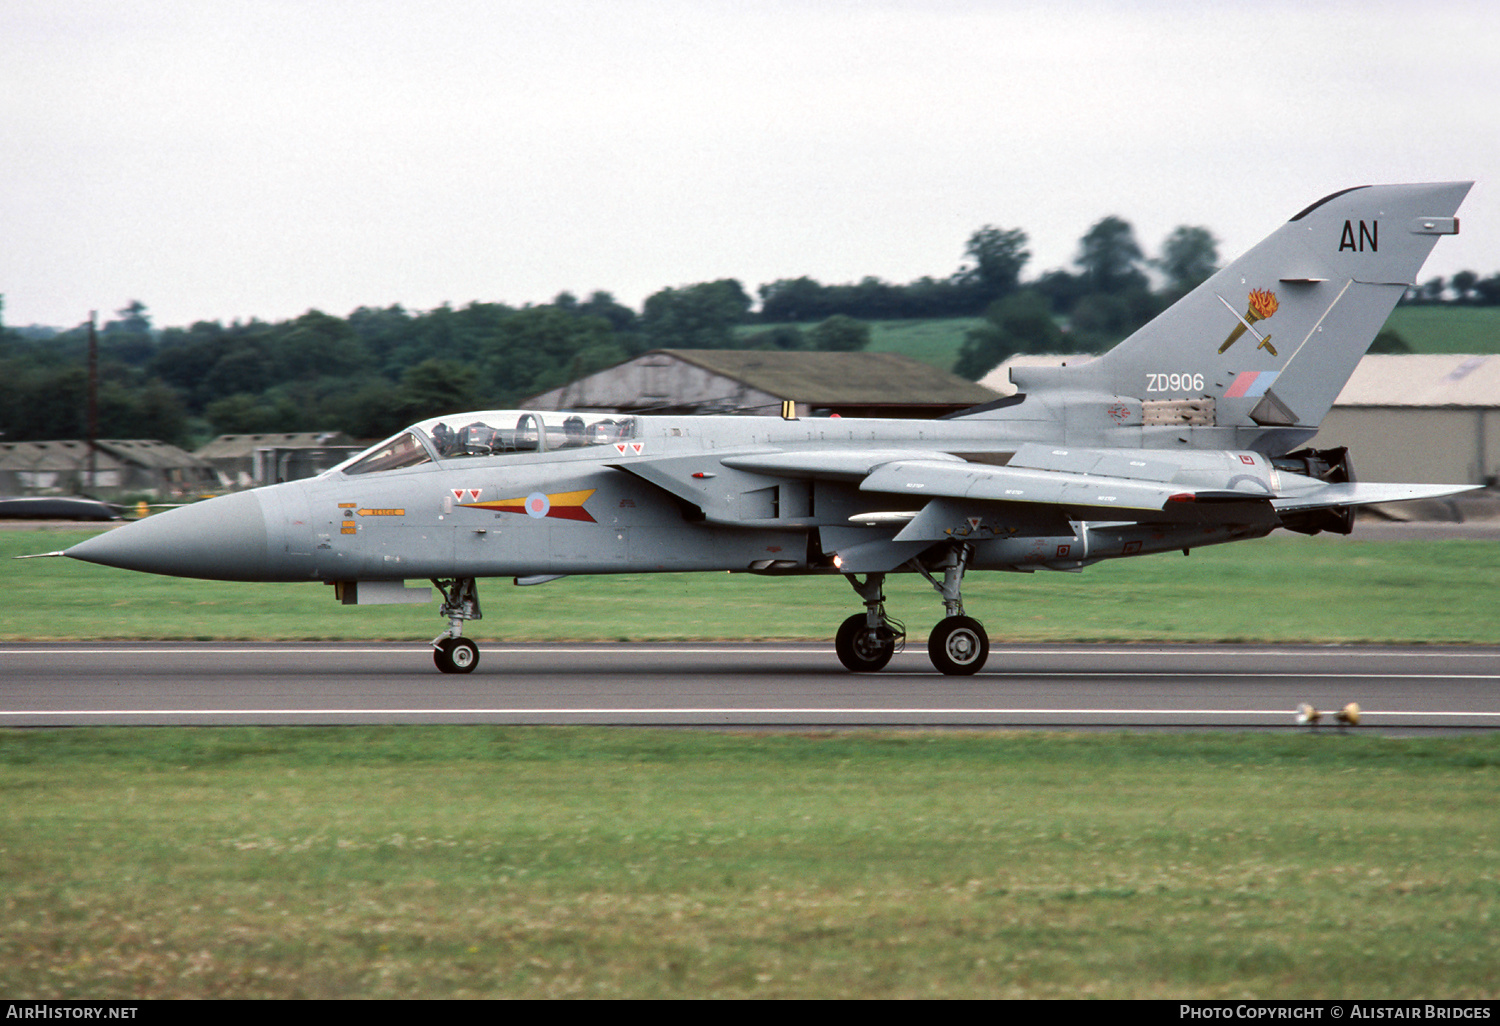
[0,531,1500,645]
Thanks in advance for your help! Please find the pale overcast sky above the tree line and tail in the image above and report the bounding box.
[0,0,1500,327]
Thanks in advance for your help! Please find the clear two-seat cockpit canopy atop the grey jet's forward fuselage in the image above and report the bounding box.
[335,410,636,474]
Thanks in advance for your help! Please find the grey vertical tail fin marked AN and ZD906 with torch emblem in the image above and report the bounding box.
[1011,182,1473,437]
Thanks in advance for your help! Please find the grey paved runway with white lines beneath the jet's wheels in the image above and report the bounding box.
[0,642,1500,734]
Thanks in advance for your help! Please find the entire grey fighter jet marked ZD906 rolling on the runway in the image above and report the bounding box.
[57,182,1472,674]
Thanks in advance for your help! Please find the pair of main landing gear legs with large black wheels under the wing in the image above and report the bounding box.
[834,545,990,677]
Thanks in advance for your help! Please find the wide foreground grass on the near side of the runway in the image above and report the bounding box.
[0,728,1500,999]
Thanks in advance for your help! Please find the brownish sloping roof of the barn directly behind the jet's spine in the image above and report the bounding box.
[657,350,996,407]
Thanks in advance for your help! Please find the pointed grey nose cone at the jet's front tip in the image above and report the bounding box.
[63,492,267,581]
